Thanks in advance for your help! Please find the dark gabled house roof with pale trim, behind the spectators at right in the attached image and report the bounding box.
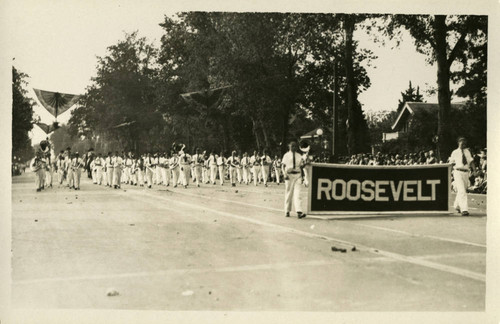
[382,102,465,142]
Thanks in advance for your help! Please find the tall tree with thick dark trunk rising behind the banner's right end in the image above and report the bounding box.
[385,15,487,159]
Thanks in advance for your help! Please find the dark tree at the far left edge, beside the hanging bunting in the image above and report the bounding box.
[12,66,35,160]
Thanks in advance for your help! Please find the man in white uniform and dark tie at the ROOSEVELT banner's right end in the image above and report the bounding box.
[450,137,476,216]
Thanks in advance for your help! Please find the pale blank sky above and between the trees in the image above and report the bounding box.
[0,0,460,142]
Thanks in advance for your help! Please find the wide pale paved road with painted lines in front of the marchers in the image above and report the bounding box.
[12,173,486,312]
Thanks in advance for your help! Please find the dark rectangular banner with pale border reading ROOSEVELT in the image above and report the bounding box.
[308,163,451,214]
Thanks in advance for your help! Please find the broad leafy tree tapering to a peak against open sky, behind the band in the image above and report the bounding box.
[69,32,162,152]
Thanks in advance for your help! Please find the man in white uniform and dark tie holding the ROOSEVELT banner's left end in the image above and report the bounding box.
[281,141,306,218]
